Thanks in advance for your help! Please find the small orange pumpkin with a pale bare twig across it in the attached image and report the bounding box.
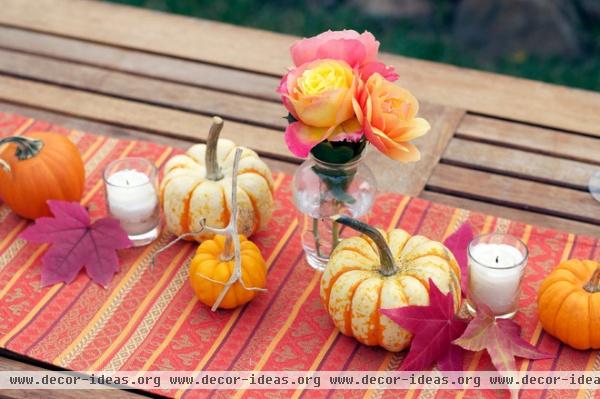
[190,235,267,309]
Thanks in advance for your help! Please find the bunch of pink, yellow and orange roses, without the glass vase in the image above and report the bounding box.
[277,30,429,163]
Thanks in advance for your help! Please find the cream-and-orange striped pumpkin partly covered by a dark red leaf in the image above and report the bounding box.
[321,216,461,352]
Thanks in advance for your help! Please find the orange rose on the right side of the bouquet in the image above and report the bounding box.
[353,73,430,162]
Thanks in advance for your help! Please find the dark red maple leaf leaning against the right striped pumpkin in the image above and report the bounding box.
[381,279,467,371]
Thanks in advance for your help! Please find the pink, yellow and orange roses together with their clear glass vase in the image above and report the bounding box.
[277,30,429,269]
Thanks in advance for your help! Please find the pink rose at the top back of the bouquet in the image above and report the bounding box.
[290,30,398,82]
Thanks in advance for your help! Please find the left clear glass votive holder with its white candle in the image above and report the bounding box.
[103,158,160,247]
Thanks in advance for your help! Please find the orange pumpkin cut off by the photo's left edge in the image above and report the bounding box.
[0,132,85,219]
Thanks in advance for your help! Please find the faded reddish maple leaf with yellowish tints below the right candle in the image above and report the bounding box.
[454,304,554,372]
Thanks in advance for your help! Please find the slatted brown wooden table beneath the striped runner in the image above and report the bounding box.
[0,0,600,398]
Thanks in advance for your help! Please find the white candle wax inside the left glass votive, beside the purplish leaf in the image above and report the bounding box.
[106,169,159,236]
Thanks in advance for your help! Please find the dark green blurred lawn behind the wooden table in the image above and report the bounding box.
[107,0,600,91]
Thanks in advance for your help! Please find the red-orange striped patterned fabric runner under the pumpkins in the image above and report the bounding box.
[0,113,600,399]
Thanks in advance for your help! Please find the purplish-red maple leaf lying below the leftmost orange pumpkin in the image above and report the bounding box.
[20,200,132,287]
